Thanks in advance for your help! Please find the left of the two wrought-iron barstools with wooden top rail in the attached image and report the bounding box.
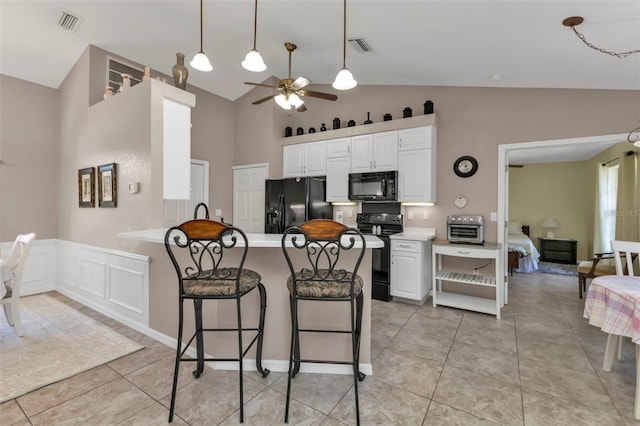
[164,219,269,423]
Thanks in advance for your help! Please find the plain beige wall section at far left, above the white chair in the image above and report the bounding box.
[0,75,60,241]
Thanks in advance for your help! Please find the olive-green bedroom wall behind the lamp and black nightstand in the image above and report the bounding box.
[509,161,595,259]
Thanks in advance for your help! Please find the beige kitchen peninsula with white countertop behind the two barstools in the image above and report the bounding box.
[118,228,383,374]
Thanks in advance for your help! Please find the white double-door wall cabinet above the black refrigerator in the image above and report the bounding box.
[282,141,327,178]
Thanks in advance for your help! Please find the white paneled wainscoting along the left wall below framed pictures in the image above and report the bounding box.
[0,239,150,332]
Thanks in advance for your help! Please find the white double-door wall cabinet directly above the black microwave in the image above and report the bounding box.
[351,130,398,173]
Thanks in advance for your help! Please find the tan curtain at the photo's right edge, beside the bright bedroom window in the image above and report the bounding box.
[615,151,640,241]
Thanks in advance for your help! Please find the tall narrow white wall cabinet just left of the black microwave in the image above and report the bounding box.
[326,138,351,202]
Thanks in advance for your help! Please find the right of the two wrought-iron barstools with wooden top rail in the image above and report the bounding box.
[282,219,366,425]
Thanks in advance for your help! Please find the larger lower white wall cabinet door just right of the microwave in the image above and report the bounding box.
[398,149,436,202]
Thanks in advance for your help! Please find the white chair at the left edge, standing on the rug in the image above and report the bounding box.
[0,232,36,336]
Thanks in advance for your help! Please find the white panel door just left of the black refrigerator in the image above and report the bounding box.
[233,164,269,234]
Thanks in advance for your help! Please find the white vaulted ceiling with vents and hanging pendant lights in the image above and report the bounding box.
[0,0,640,100]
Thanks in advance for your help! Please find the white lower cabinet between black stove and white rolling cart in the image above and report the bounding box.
[391,239,431,303]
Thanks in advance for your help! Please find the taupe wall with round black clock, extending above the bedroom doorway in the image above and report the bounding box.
[234,85,640,241]
